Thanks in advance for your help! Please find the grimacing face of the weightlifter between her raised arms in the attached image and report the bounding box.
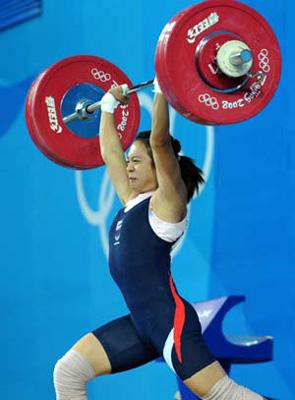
[126,141,158,194]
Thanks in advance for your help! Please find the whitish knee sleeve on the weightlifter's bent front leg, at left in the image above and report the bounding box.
[53,350,95,400]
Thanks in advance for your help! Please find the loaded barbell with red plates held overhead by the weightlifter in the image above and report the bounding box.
[26,0,281,169]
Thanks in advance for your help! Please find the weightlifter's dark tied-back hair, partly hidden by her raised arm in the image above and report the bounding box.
[135,131,205,202]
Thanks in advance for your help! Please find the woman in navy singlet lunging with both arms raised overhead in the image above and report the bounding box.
[54,80,262,400]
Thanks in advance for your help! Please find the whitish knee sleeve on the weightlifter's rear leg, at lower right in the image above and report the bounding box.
[202,375,263,400]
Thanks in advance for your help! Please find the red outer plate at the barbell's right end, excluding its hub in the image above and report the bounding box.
[155,0,281,125]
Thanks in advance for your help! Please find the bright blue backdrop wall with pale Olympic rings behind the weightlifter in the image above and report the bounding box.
[0,0,295,400]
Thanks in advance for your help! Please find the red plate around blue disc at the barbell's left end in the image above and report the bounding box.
[26,56,140,169]
